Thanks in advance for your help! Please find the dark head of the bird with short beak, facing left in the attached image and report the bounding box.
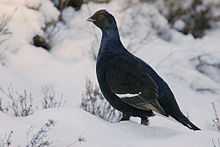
[87,9,117,31]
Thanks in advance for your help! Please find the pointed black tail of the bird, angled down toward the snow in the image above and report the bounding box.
[172,113,201,131]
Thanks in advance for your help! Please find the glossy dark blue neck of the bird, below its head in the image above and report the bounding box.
[99,28,125,54]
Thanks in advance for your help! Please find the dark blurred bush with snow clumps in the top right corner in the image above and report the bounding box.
[157,0,220,38]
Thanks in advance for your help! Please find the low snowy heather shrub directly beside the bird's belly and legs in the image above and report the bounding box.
[81,80,122,122]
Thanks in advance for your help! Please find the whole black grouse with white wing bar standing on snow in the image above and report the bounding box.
[88,10,200,130]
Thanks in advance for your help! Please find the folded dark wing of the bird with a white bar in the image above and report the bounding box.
[106,55,164,113]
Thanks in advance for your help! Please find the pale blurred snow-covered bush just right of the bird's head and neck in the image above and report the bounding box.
[119,0,172,51]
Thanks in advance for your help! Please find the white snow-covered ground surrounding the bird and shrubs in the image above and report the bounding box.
[0,0,220,147]
